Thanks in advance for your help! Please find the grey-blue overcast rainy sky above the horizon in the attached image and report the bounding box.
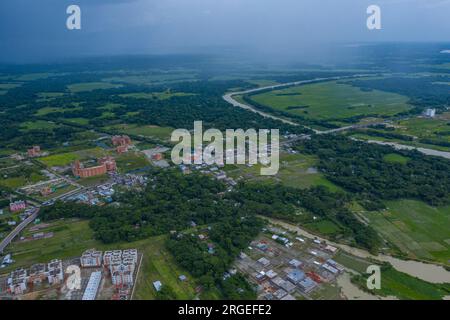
[0,0,450,62]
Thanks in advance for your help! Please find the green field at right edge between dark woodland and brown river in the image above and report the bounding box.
[362,200,450,265]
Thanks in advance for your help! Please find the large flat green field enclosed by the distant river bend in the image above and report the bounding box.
[251,81,411,120]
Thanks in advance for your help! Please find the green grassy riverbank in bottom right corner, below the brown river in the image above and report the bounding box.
[334,252,450,300]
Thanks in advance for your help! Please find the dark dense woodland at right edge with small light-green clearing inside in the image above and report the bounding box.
[297,135,450,205]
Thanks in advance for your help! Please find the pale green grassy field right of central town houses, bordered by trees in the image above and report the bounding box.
[226,154,339,191]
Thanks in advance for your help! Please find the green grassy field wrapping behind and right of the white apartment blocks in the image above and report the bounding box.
[2,219,196,299]
